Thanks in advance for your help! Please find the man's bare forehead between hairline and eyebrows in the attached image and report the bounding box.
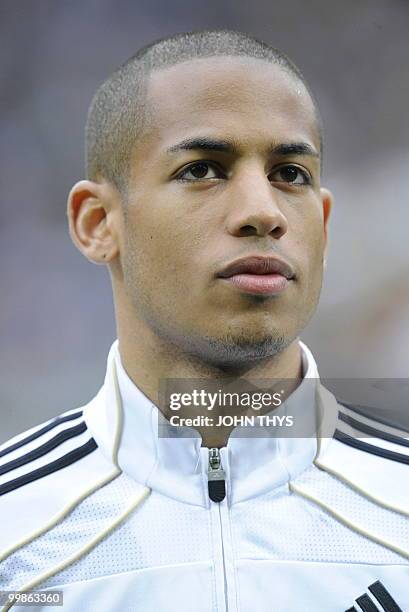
[142,56,319,154]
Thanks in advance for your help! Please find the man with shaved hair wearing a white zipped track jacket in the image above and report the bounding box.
[0,31,409,612]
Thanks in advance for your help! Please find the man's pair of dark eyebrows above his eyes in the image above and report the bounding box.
[166,136,320,157]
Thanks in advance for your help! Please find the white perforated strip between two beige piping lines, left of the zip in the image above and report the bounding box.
[1,474,148,590]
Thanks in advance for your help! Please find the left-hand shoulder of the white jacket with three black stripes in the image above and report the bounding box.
[0,406,117,558]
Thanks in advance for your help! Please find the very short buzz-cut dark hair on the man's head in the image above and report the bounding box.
[85,30,322,195]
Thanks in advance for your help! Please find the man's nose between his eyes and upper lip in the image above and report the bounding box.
[227,169,288,239]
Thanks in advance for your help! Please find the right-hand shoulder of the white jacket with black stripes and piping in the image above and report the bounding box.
[290,389,409,559]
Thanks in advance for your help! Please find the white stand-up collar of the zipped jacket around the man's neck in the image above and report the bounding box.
[84,340,334,506]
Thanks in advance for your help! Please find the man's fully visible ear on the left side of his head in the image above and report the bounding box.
[67,180,119,264]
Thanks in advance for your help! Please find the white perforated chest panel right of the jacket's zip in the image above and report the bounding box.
[231,483,407,564]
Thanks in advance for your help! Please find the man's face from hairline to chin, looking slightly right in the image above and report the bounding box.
[116,57,329,365]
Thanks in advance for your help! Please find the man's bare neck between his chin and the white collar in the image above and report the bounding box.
[117,304,302,447]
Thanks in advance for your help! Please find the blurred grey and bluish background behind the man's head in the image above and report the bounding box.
[0,0,409,442]
